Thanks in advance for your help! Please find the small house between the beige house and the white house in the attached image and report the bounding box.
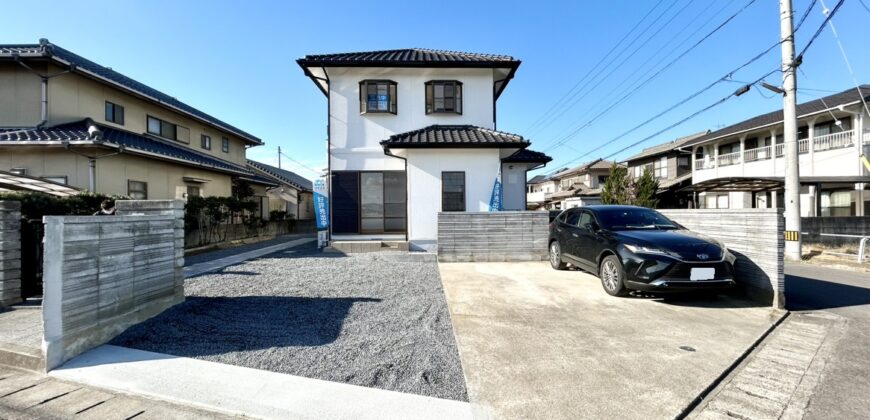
[248,159,314,220]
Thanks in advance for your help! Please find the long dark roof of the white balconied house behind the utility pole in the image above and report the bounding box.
[683,85,870,147]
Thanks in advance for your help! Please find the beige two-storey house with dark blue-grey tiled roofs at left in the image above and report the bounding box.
[0,39,263,199]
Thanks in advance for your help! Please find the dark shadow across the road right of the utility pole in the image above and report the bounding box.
[785,275,870,310]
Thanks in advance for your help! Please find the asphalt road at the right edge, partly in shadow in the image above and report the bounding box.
[785,263,870,419]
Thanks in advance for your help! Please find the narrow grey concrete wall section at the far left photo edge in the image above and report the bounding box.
[0,201,21,306]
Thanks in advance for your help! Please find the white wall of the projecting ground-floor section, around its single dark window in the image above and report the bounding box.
[407,149,500,249]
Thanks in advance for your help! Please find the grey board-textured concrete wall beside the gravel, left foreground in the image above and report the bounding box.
[42,200,184,370]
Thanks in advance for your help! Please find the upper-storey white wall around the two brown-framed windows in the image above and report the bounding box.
[328,68,494,171]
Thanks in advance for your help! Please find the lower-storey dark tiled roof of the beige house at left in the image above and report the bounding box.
[0,121,250,175]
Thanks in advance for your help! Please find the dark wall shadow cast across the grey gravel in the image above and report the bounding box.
[109,296,381,357]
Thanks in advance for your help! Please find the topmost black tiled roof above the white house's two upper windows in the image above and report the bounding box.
[296,48,520,67]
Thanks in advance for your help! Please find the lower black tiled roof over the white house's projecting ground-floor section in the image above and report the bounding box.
[381,125,529,149]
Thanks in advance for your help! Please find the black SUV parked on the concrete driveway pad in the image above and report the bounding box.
[548,205,736,296]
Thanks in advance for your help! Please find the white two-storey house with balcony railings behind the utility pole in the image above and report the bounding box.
[681,85,870,217]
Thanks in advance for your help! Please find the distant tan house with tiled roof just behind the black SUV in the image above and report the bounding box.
[539,159,621,210]
